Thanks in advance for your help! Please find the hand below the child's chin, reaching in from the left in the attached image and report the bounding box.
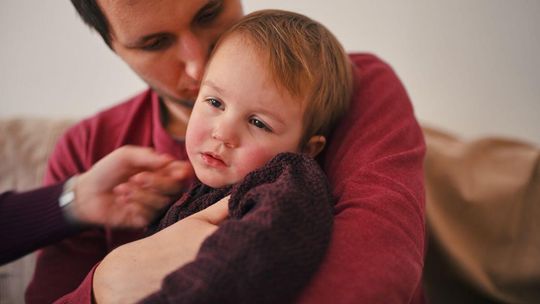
[66,146,193,228]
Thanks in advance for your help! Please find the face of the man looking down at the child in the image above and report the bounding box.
[98,0,243,104]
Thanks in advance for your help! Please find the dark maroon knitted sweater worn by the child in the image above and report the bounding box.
[143,153,332,304]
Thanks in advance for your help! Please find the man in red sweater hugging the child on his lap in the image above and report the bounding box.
[26,0,425,303]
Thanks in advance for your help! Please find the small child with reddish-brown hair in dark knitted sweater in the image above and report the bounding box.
[145,10,352,303]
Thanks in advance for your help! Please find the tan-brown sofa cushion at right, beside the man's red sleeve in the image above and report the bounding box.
[424,127,540,303]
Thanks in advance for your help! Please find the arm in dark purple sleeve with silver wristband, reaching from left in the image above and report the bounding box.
[0,146,191,264]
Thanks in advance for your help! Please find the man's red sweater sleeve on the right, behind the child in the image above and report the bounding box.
[299,54,425,304]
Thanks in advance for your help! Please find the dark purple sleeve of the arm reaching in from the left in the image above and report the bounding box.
[0,183,77,264]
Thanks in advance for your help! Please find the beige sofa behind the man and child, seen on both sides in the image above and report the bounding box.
[0,118,540,304]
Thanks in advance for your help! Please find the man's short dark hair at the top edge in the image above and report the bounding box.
[71,0,112,49]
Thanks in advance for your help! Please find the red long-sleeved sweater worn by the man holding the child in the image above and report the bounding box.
[30,54,425,304]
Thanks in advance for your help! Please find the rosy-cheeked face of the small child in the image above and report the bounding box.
[186,35,304,188]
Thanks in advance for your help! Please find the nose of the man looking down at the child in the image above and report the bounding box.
[178,31,208,83]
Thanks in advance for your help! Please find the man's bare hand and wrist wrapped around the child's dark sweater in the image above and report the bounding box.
[93,196,229,304]
